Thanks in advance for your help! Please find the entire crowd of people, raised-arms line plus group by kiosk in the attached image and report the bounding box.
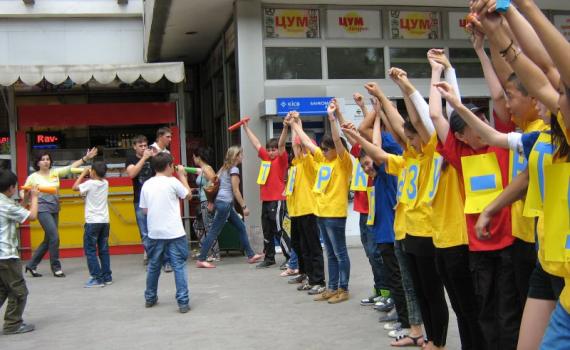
[0,0,570,349]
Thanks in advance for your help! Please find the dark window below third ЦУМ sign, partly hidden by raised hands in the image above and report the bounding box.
[390,47,431,78]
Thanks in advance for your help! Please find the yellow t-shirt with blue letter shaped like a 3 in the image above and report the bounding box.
[386,138,437,237]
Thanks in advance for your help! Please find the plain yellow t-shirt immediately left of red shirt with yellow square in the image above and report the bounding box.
[432,164,468,248]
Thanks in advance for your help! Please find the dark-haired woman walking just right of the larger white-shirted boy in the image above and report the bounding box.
[192,147,220,261]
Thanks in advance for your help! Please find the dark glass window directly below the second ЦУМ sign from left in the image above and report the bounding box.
[327,47,384,79]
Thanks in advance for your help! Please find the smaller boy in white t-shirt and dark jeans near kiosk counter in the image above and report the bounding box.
[73,161,113,288]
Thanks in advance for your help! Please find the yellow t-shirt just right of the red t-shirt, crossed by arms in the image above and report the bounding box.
[509,119,549,243]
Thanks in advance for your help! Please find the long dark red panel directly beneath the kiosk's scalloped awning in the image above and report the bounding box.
[18,102,176,128]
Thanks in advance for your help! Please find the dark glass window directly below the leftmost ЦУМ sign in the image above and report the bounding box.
[265,47,323,79]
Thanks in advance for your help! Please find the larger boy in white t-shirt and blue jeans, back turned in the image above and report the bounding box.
[139,152,191,313]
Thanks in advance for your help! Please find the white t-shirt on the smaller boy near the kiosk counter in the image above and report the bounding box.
[79,179,109,224]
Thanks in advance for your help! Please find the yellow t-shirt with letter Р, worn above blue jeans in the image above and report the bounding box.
[309,147,352,218]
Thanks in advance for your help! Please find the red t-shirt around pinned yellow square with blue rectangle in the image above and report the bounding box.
[437,130,514,251]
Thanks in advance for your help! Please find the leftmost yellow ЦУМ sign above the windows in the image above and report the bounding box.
[263,8,319,39]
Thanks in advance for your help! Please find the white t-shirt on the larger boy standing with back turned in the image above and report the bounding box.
[139,176,188,239]
